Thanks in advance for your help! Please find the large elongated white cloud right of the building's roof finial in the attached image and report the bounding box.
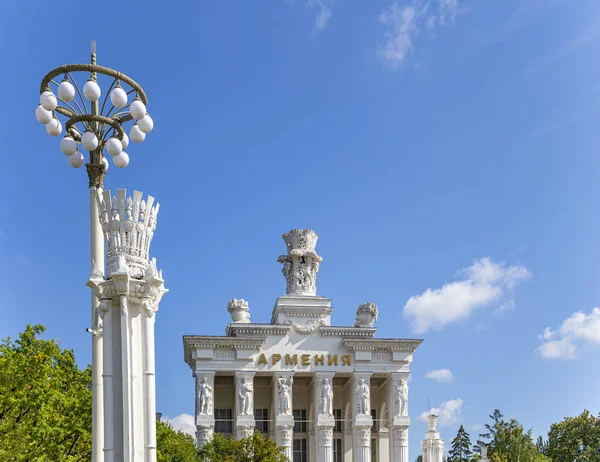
[403,257,531,334]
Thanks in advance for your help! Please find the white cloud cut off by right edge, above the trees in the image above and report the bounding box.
[536,307,600,359]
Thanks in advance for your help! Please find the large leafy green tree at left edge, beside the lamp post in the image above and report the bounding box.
[0,325,92,462]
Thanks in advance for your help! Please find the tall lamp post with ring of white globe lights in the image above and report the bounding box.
[35,41,154,462]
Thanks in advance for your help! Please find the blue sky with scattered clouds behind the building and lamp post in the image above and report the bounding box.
[0,0,600,460]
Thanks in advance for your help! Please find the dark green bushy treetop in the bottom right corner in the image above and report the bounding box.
[545,410,600,462]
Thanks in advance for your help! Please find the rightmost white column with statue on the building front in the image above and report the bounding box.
[388,372,410,462]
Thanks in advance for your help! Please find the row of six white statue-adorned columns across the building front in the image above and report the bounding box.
[195,371,410,462]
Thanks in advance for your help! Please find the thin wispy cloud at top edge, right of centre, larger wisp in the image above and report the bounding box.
[377,0,459,67]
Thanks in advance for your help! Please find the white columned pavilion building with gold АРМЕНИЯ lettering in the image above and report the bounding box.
[183,230,421,462]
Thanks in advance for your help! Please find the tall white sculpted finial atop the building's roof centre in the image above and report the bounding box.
[277,229,323,295]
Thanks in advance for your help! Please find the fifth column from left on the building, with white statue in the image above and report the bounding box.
[351,372,375,462]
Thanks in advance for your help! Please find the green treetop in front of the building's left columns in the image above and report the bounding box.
[200,432,288,462]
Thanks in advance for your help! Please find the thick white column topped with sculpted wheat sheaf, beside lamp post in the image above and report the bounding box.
[88,189,167,462]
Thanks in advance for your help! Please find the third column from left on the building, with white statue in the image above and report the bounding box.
[273,371,294,460]
